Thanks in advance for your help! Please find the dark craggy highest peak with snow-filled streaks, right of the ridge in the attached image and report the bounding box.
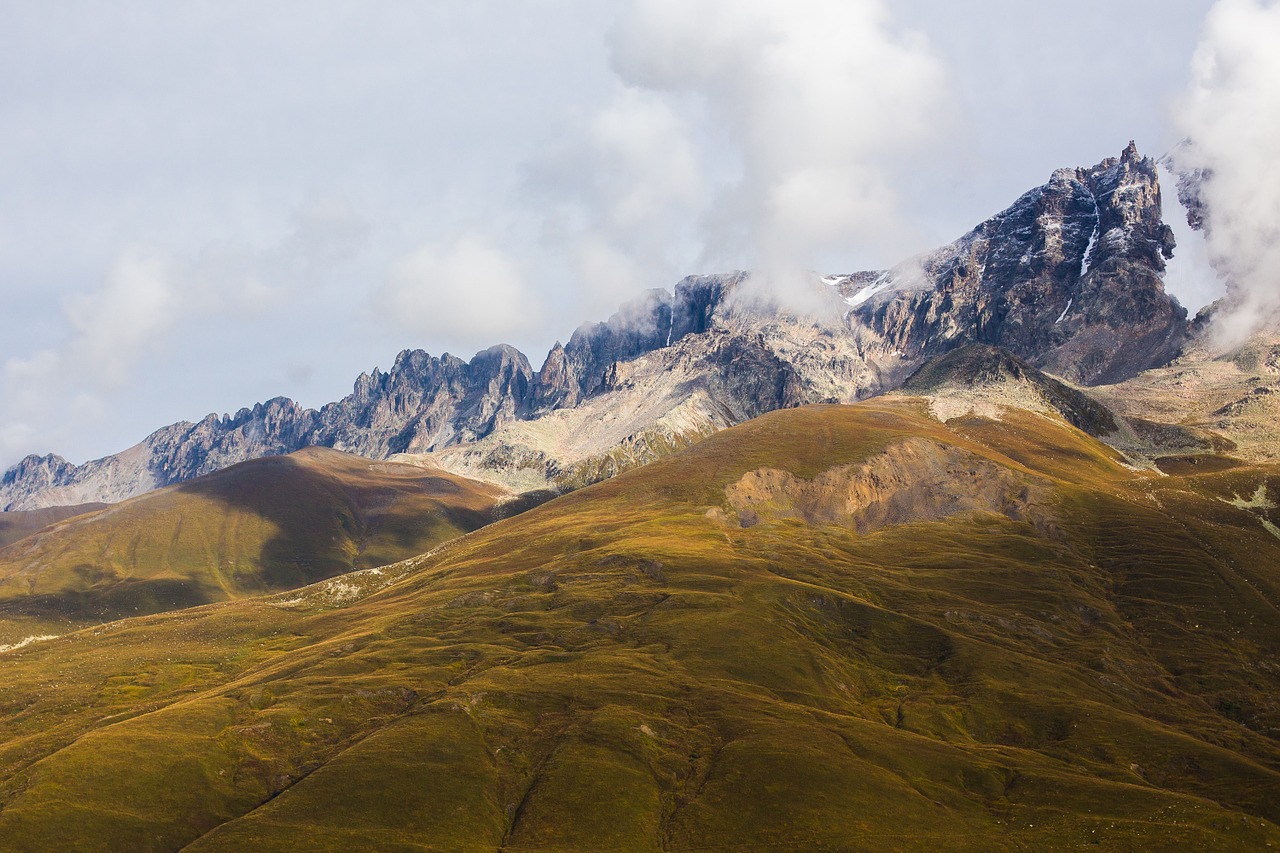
[841,142,1187,384]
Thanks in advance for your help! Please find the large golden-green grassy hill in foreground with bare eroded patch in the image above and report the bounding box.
[0,400,1280,853]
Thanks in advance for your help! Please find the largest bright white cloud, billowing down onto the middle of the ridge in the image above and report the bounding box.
[613,0,948,312]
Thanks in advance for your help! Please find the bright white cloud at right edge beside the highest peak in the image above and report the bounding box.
[1175,0,1280,346]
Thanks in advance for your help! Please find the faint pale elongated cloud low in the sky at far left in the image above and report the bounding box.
[0,199,369,459]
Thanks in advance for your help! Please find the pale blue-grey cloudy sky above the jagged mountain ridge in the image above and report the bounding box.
[0,0,1259,466]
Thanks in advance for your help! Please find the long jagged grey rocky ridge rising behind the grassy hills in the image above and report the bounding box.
[0,143,1188,510]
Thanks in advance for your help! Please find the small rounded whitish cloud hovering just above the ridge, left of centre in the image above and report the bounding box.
[376,233,543,350]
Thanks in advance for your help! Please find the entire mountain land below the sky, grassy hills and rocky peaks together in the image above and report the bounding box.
[0,143,1280,853]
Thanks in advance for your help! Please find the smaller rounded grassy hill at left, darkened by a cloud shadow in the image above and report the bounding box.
[0,448,503,643]
